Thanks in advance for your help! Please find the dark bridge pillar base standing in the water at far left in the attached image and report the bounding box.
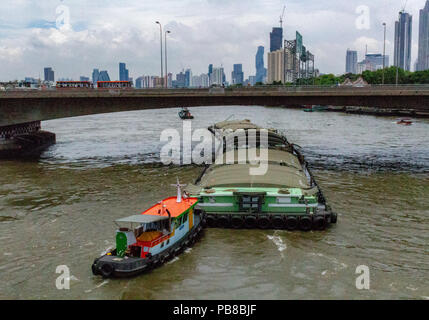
[0,121,55,159]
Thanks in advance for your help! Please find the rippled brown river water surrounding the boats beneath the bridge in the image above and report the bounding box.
[0,107,429,299]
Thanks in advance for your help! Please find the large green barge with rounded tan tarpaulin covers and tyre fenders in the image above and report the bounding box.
[186,120,337,231]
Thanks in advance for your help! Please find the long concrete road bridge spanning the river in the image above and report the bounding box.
[0,85,429,130]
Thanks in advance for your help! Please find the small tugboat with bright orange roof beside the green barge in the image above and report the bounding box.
[92,180,205,278]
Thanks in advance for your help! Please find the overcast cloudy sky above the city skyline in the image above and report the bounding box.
[0,0,426,81]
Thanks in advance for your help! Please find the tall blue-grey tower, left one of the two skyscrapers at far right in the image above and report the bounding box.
[394,11,413,71]
